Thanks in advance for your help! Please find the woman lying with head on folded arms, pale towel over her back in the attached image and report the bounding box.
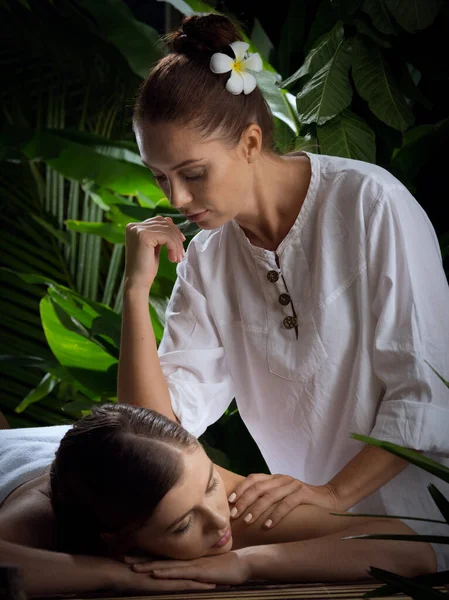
[0,404,436,594]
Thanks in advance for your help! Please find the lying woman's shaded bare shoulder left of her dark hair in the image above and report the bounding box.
[0,475,56,550]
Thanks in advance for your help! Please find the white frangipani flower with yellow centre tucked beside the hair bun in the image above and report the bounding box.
[210,42,262,95]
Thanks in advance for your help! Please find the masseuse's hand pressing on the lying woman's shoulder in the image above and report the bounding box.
[228,473,341,528]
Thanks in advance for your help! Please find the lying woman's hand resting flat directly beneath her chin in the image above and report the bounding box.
[128,550,250,585]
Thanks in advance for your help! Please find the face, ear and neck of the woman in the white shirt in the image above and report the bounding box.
[135,123,311,250]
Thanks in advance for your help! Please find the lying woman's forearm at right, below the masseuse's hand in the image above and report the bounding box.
[237,520,436,582]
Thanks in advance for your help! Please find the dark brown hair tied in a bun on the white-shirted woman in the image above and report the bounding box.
[134,14,274,150]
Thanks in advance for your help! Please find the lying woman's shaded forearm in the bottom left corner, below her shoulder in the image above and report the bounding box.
[0,540,115,595]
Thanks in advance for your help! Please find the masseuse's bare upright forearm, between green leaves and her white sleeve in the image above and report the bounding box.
[118,282,176,420]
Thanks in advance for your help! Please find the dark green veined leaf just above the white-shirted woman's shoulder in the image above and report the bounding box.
[317,110,376,163]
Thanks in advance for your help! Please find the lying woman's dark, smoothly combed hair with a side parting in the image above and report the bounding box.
[50,403,199,552]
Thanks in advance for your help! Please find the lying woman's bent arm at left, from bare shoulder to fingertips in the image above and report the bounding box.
[0,489,211,595]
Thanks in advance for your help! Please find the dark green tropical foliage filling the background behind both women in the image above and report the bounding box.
[0,0,449,472]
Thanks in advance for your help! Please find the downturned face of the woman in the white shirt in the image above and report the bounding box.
[135,123,260,229]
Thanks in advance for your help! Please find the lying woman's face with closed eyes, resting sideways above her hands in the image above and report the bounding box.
[125,447,232,559]
